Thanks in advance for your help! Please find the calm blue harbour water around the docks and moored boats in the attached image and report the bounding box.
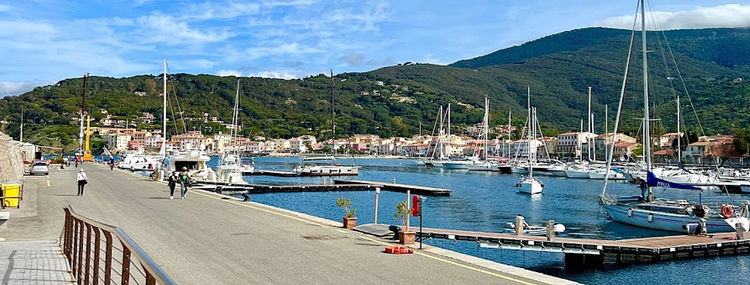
[212,157,750,284]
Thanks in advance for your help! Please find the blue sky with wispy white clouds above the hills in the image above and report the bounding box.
[0,0,750,97]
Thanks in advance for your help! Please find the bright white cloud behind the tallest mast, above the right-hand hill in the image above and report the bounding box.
[596,4,750,30]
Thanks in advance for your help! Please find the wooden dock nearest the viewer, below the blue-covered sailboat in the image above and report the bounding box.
[417,228,750,268]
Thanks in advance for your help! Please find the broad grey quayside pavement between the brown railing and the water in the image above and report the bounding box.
[0,164,570,284]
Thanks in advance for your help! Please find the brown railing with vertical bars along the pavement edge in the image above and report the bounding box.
[61,206,176,285]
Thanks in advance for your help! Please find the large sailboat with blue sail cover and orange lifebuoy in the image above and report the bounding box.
[600,0,750,233]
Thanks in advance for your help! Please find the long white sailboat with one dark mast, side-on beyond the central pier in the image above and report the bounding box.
[294,70,359,176]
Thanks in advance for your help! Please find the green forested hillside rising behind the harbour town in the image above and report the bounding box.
[0,28,750,151]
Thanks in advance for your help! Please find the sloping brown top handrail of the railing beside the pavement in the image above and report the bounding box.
[65,205,177,285]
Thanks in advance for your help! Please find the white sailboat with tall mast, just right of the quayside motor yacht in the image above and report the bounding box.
[214,79,255,184]
